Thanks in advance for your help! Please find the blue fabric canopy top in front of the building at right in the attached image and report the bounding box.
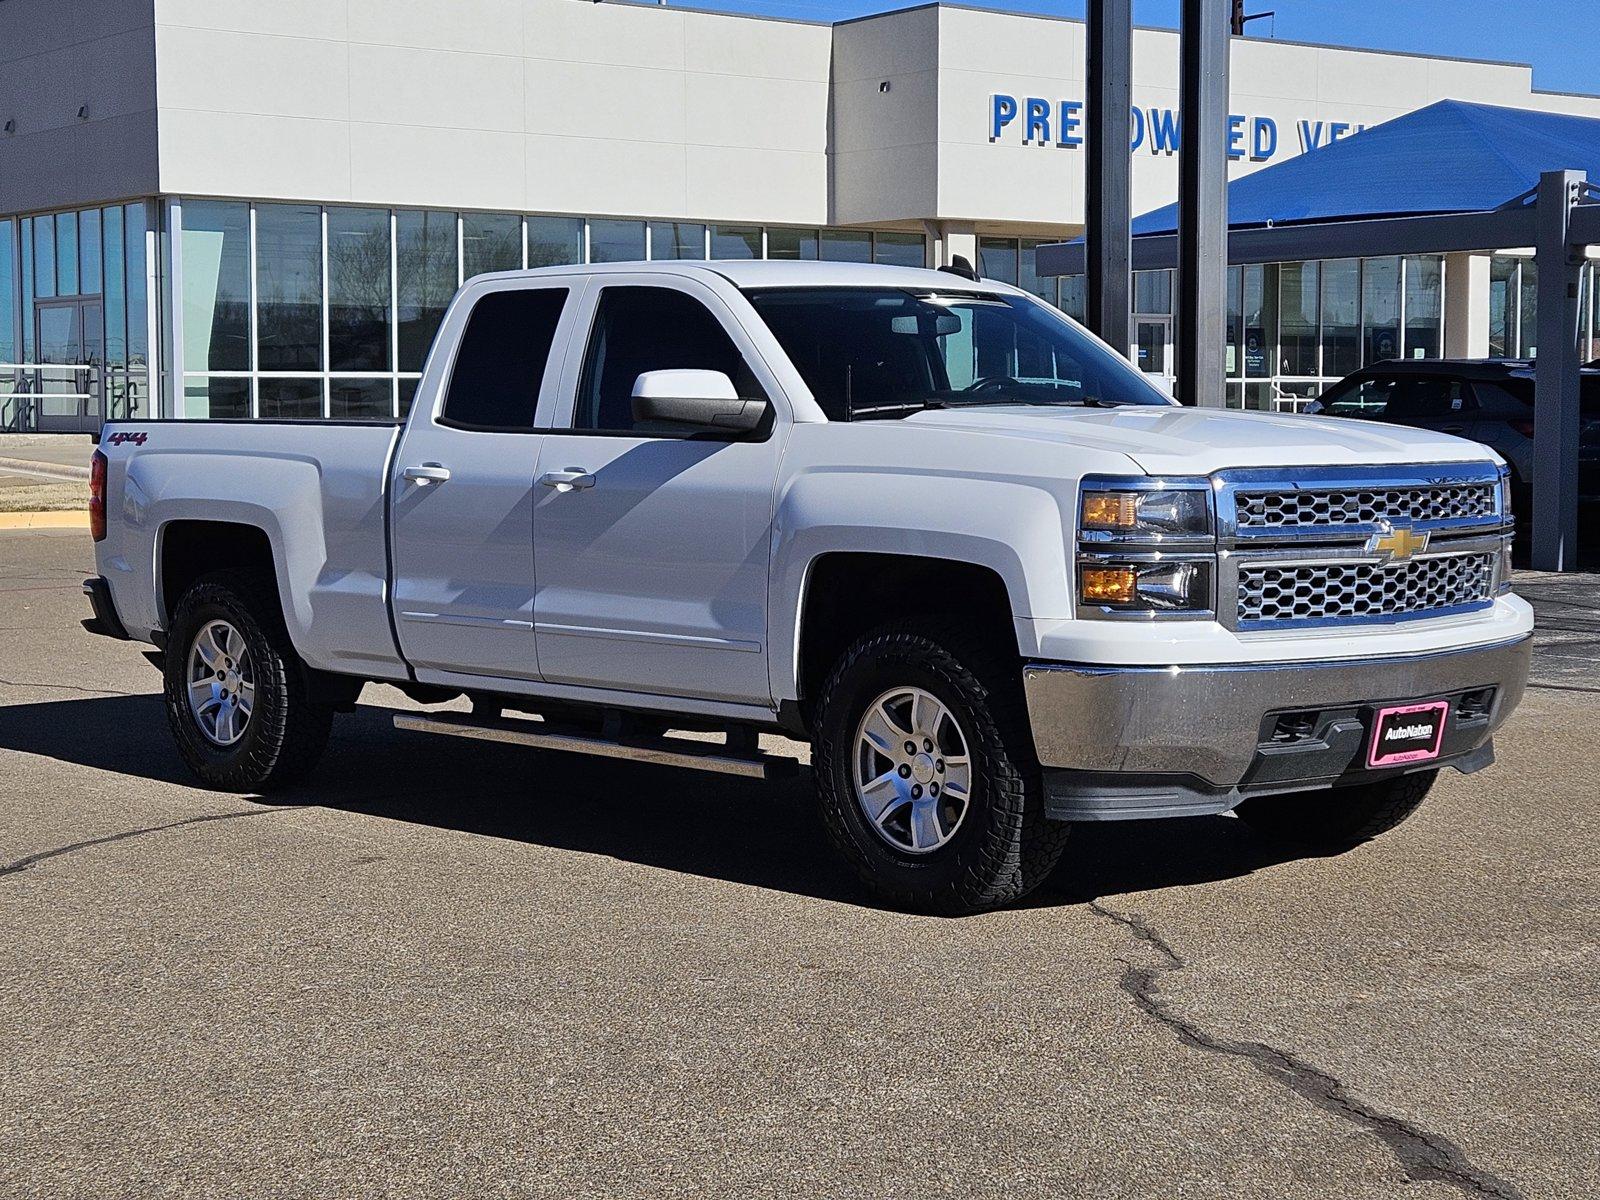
[1133,99,1600,237]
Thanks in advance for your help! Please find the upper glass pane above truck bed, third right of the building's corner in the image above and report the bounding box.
[328,208,392,371]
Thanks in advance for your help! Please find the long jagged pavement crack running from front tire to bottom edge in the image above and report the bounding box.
[1090,901,1526,1200]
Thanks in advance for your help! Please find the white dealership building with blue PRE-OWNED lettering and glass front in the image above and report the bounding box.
[0,0,1600,430]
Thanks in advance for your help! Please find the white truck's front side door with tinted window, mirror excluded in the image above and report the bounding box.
[533,275,787,706]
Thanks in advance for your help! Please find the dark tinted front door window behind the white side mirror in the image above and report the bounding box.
[573,288,765,432]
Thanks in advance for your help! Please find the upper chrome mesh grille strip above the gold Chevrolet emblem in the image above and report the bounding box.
[1234,483,1498,531]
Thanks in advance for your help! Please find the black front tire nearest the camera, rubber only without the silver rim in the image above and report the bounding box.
[813,621,1069,915]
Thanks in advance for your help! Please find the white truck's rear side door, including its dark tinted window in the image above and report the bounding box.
[389,277,581,685]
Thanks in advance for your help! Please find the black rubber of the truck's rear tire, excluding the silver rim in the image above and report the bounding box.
[163,573,333,792]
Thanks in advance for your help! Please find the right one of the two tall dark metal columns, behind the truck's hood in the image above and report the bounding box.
[1176,0,1229,408]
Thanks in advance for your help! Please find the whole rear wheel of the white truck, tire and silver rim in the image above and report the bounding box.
[165,573,333,792]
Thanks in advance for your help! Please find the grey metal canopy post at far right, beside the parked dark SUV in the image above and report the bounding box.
[1533,171,1584,571]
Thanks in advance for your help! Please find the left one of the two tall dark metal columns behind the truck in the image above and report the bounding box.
[1083,0,1133,354]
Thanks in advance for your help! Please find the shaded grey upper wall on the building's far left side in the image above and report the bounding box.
[0,0,155,213]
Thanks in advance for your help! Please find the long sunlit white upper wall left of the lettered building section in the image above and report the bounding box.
[155,0,832,222]
